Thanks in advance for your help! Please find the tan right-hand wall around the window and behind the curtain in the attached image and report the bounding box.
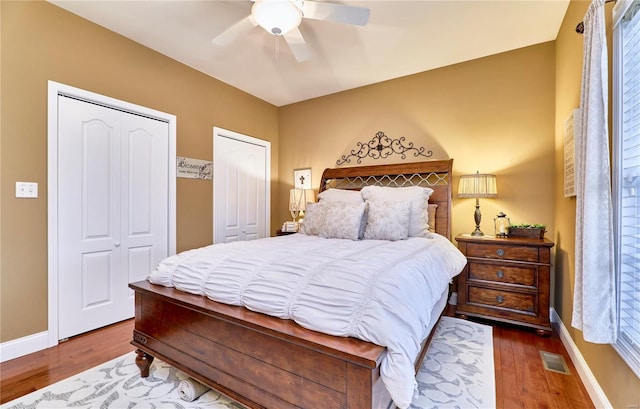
[553,0,640,408]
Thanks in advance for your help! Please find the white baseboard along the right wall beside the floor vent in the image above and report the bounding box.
[550,307,613,409]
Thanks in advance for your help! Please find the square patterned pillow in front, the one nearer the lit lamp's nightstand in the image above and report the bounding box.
[364,201,411,241]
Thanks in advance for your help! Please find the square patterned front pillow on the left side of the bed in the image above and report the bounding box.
[320,202,366,240]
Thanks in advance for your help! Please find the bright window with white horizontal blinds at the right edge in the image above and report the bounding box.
[613,0,640,377]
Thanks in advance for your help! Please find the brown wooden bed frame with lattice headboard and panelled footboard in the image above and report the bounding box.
[130,160,453,409]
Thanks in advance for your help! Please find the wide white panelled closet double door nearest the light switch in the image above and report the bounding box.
[58,96,168,339]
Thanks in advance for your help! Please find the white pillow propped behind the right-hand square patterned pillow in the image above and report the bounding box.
[360,186,433,237]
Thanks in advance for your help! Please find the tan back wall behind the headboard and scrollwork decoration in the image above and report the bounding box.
[278,42,555,242]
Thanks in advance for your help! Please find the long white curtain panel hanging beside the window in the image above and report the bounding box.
[571,0,616,344]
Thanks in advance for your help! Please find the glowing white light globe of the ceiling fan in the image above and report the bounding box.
[251,0,302,36]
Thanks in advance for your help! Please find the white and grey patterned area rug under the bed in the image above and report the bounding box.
[0,317,495,409]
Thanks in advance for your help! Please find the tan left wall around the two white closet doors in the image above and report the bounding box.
[0,1,278,342]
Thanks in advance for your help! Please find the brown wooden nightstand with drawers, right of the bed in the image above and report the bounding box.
[456,234,554,335]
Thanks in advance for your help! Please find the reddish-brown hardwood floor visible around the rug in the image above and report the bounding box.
[0,320,594,409]
